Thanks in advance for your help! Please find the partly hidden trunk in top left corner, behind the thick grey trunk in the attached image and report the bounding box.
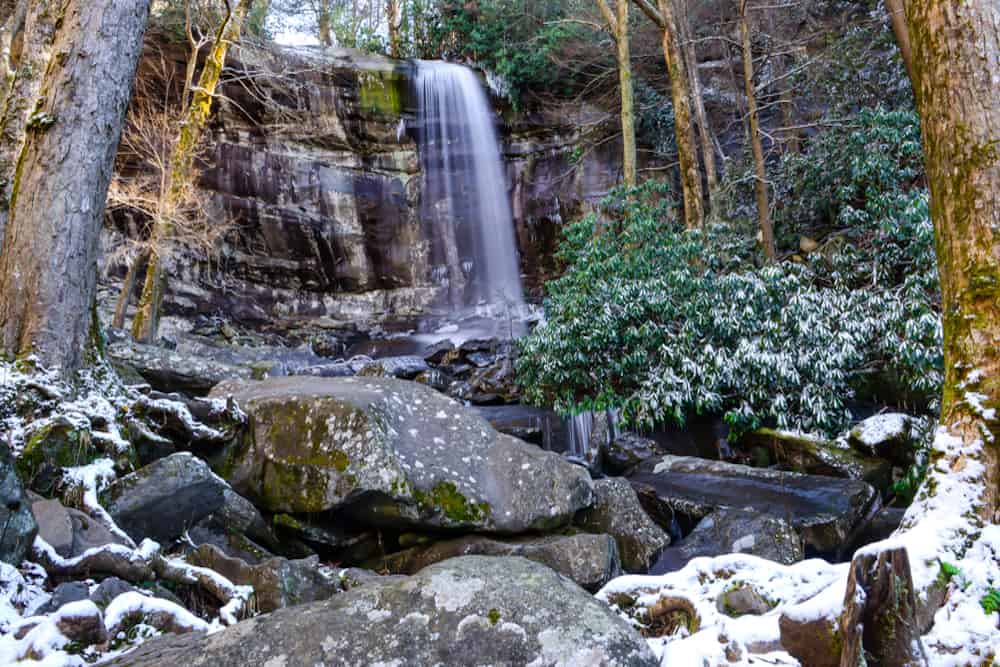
[0,0,60,250]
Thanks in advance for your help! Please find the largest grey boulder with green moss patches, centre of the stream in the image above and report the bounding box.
[212,377,593,533]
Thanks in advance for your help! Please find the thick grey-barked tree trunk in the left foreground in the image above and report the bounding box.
[0,0,149,374]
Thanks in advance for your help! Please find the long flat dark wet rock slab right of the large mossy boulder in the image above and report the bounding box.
[629,456,877,552]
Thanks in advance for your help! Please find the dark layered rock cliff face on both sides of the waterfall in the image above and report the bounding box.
[101,41,620,328]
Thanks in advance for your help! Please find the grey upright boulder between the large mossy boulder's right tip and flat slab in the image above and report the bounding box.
[574,478,670,572]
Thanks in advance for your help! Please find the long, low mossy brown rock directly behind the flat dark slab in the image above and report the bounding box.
[740,428,892,490]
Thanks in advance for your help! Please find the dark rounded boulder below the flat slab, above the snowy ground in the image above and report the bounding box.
[652,509,803,574]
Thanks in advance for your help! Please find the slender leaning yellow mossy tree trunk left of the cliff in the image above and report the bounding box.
[132,0,252,343]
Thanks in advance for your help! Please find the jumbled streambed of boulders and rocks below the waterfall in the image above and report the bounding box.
[0,335,914,665]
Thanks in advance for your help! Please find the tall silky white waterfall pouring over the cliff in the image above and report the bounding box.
[415,61,524,314]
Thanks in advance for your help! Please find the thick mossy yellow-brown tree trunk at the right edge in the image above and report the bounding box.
[906,0,1000,521]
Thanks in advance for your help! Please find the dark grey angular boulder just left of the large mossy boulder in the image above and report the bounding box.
[101,452,228,542]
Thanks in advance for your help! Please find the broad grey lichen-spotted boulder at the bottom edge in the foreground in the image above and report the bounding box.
[101,556,658,667]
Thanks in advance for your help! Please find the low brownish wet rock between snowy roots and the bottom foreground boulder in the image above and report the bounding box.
[188,544,343,614]
